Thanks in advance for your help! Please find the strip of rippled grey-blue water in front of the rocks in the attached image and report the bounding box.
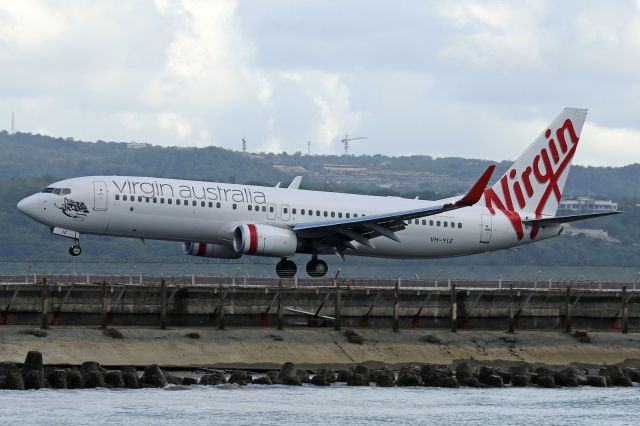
[0,385,640,426]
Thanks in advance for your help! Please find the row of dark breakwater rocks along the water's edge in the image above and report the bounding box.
[0,351,640,390]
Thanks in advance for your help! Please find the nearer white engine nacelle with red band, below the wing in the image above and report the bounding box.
[233,223,298,257]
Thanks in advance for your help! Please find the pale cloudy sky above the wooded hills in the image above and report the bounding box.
[0,0,640,166]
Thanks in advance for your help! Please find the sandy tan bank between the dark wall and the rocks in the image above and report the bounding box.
[0,326,640,369]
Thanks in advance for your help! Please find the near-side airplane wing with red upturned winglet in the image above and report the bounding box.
[293,165,496,253]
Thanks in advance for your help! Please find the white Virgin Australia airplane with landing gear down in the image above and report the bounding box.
[18,108,615,277]
